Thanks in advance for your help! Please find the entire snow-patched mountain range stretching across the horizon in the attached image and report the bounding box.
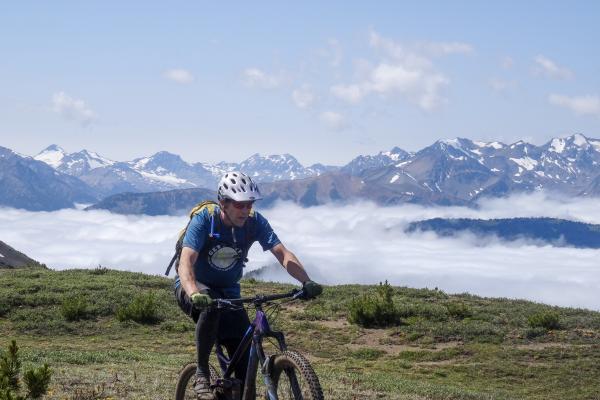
[0,134,600,213]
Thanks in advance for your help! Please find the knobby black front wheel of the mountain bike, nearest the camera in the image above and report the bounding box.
[267,351,323,400]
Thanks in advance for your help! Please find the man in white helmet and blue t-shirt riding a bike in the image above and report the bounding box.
[175,171,322,400]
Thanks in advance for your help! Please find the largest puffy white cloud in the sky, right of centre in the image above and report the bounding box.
[330,32,462,111]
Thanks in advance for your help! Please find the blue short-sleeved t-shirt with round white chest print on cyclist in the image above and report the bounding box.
[175,207,281,298]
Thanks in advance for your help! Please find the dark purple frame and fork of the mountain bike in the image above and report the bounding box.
[215,301,298,400]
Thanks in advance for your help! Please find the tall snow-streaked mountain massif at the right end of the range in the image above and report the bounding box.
[365,134,600,204]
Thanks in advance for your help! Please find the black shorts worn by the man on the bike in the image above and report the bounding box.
[175,285,250,340]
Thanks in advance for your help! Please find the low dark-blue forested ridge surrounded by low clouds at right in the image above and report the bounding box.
[406,218,600,249]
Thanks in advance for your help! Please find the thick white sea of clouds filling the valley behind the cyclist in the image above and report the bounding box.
[0,193,600,310]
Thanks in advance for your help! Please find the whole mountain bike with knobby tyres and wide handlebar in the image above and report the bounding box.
[175,289,323,400]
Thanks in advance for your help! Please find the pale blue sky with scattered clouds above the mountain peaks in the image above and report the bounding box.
[0,1,600,165]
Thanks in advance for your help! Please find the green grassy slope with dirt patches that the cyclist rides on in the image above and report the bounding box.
[0,268,600,399]
